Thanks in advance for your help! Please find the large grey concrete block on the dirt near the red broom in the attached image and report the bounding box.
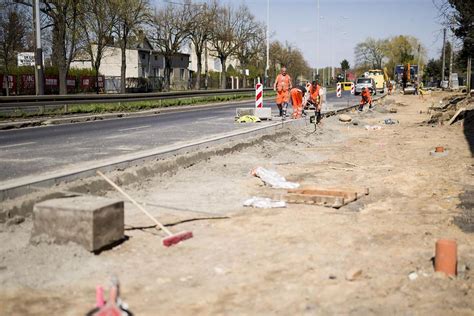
[31,196,124,251]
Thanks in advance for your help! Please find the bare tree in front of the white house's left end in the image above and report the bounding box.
[80,0,117,93]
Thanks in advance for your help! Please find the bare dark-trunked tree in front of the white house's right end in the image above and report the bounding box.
[153,1,192,90]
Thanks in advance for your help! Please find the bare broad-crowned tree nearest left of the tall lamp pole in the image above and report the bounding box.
[211,5,256,89]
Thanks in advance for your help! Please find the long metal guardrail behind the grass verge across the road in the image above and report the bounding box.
[0,88,271,108]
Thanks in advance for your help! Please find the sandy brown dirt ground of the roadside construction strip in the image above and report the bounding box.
[0,93,474,315]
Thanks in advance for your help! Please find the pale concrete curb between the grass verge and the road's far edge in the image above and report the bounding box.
[0,97,273,131]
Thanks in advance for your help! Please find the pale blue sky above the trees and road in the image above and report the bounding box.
[155,0,443,68]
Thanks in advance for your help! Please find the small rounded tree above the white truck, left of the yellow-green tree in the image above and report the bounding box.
[354,37,387,69]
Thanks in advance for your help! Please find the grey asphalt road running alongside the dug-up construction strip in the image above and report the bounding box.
[0,92,359,181]
